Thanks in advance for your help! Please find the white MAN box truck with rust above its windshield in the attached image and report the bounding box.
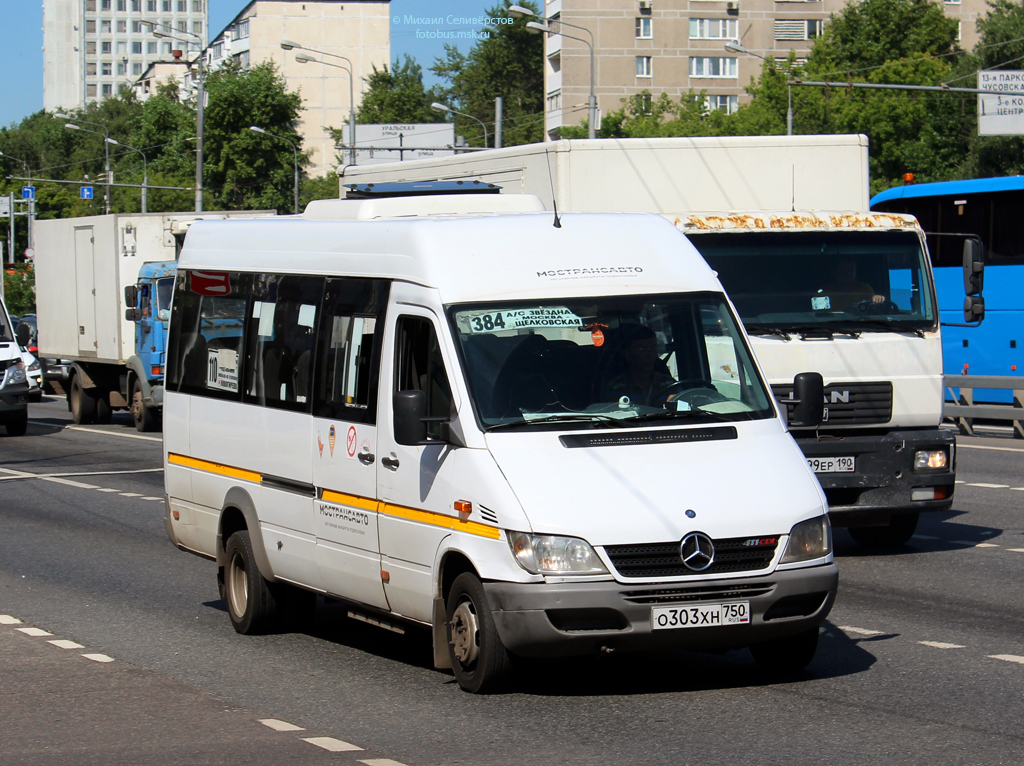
[341,135,970,546]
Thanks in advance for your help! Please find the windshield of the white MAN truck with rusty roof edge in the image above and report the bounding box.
[689,230,936,333]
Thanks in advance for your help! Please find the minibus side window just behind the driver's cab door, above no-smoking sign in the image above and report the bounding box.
[313,278,390,425]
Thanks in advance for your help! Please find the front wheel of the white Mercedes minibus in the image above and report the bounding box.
[444,572,512,694]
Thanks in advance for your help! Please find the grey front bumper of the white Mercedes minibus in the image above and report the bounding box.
[483,563,839,657]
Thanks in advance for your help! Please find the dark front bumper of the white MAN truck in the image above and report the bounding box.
[793,428,956,526]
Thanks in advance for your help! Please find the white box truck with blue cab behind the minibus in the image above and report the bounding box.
[36,211,272,431]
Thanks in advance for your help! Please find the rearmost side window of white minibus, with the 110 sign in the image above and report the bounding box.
[167,271,252,400]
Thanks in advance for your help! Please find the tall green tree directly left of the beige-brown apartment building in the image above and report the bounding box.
[430,0,544,146]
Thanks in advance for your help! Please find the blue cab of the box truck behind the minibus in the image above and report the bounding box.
[125,261,177,431]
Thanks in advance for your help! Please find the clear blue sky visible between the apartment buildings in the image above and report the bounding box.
[0,0,499,127]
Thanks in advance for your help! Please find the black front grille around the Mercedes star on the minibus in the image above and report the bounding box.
[604,535,778,578]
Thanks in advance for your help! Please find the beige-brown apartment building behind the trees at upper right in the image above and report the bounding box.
[545,0,988,139]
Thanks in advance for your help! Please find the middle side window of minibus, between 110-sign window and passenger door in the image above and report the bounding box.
[245,274,324,413]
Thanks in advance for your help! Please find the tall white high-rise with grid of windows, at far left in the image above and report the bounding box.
[43,0,208,112]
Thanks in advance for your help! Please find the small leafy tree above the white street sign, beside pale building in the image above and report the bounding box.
[355,53,444,124]
